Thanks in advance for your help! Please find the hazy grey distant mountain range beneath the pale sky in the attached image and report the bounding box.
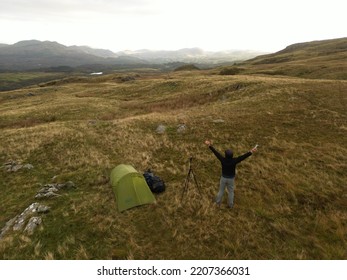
[0,40,262,71]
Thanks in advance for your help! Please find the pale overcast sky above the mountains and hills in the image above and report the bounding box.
[0,0,347,52]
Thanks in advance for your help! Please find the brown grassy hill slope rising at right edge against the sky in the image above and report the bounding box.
[222,38,347,80]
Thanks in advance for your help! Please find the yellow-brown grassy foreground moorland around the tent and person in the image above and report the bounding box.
[0,71,347,259]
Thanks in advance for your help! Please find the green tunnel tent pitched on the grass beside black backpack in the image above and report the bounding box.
[111,164,155,212]
